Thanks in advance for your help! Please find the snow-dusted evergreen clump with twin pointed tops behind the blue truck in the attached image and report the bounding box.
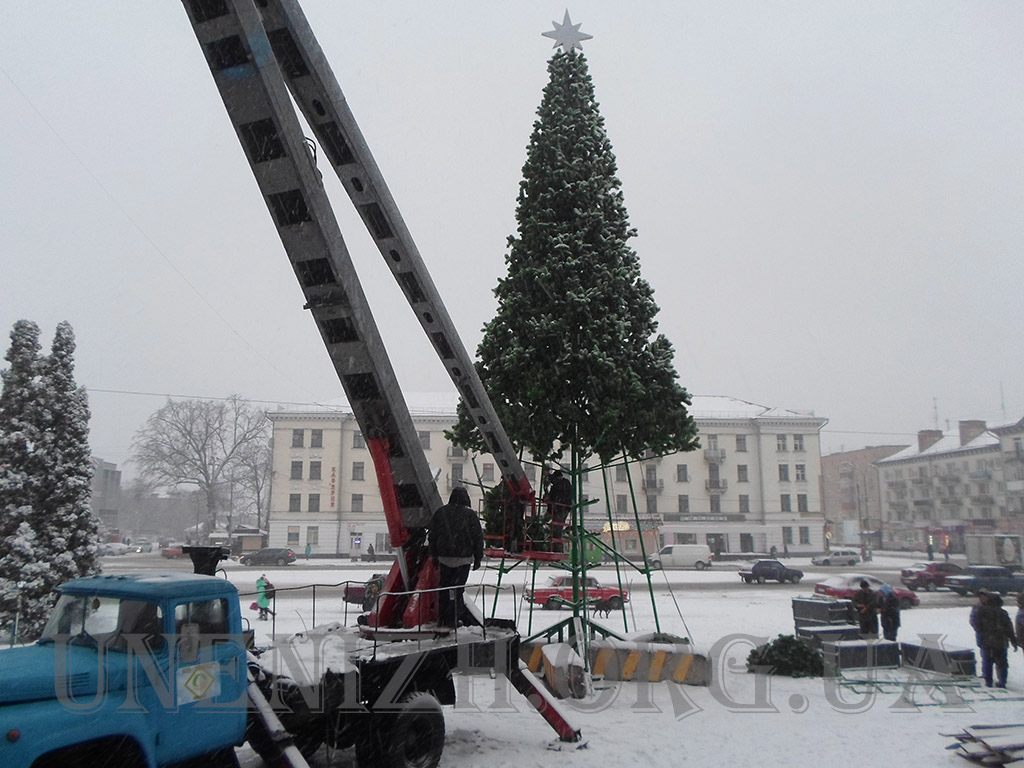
[0,321,97,639]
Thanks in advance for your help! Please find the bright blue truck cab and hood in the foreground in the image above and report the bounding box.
[0,573,248,768]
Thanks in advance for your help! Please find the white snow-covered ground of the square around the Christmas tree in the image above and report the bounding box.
[201,558,1024,768]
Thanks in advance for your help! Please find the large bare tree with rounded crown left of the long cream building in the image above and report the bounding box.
[132,395,268,530]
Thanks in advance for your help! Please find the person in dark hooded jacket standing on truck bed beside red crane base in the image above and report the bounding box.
[430,486,483,629]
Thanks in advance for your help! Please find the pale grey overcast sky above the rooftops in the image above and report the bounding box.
[0,0,1024,475]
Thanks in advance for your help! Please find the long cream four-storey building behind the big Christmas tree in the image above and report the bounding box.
[268,397,826,557]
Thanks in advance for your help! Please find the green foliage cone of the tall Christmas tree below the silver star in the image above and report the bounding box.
[454,50,697,466]
